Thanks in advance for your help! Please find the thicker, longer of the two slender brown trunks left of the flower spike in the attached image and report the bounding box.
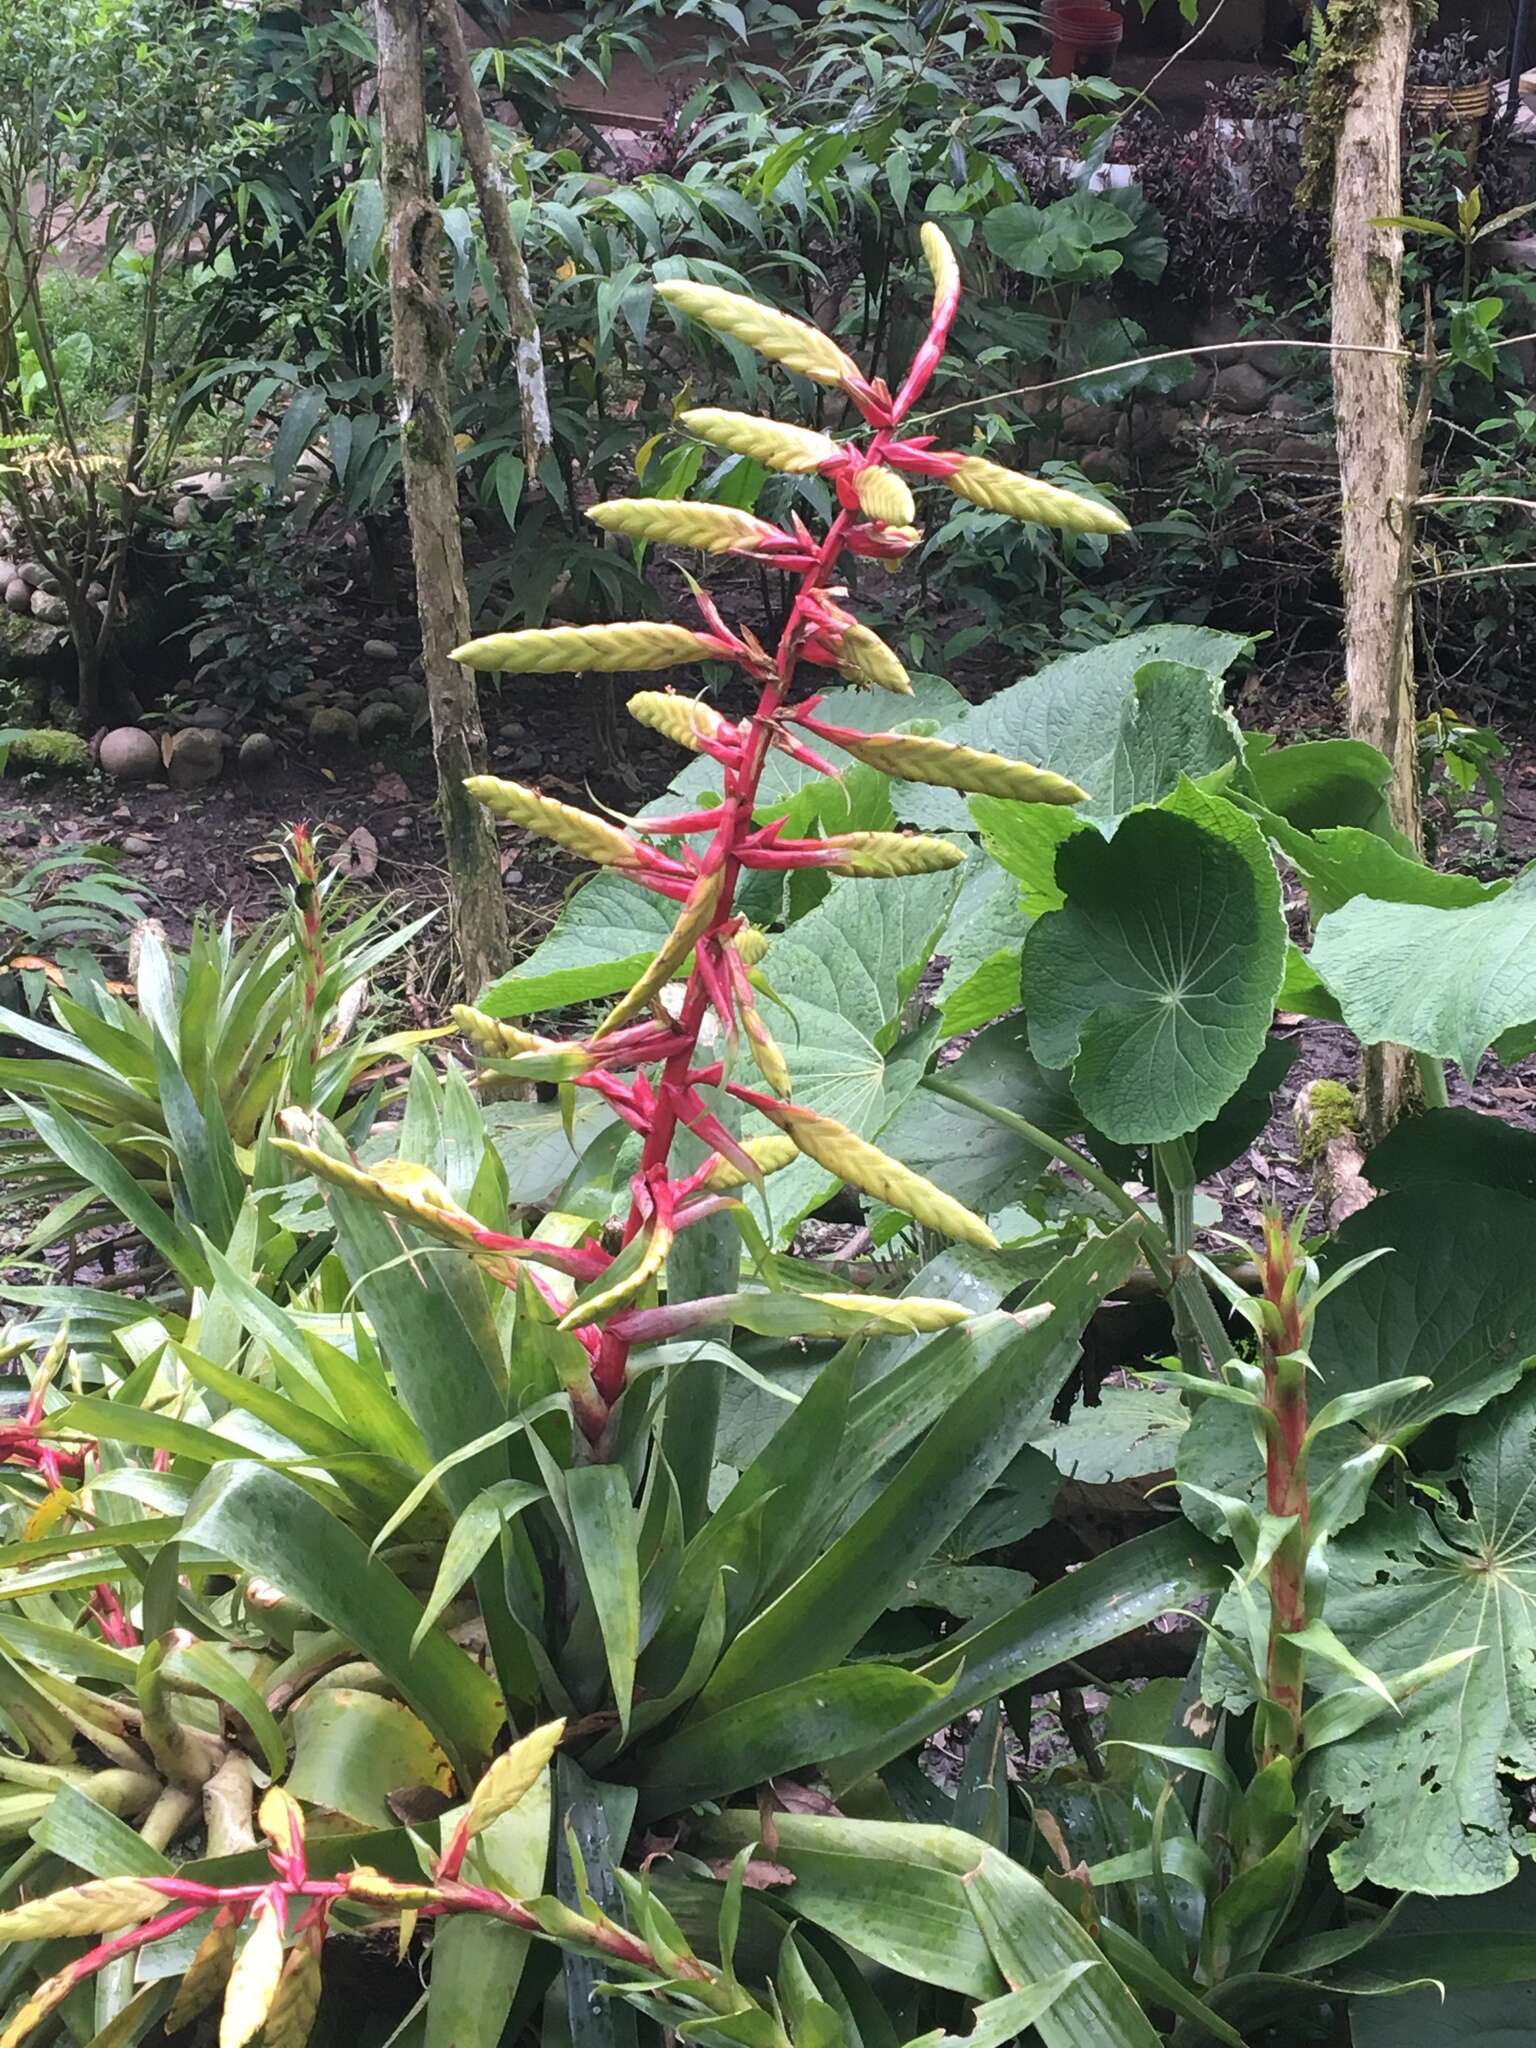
[375,0,508,995]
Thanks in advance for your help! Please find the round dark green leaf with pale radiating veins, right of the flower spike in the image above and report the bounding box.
[1024,782,1286,1145]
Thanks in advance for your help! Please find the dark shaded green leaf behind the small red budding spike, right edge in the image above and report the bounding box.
[1178,1186,1536,1534]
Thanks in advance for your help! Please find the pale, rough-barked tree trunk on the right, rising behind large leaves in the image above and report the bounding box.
[1331,0,1421,1141]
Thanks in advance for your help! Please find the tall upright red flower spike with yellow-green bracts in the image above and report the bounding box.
[291,223,1124,1446]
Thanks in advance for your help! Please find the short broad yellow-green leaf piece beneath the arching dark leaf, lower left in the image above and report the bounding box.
[287,1686,449,1827]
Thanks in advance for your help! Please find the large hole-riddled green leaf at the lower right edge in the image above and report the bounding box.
[1309,1380,1536,1894]
